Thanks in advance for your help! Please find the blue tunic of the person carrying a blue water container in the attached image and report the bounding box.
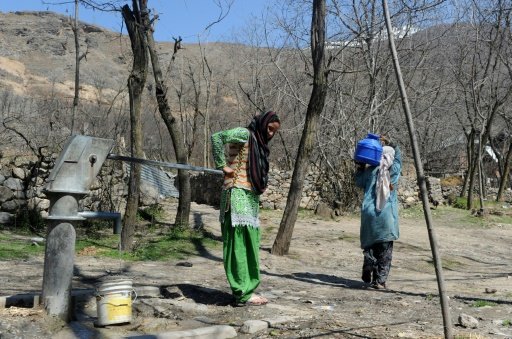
[355,146,402,249]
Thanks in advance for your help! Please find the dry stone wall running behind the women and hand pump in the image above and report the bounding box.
[0,153,512,224]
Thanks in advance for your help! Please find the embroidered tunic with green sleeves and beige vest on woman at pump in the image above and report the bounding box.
[211,127,260,227]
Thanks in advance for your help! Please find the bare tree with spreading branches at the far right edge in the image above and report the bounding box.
[453,1,512,210]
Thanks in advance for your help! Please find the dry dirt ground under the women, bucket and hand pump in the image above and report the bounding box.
[0,204,512,339]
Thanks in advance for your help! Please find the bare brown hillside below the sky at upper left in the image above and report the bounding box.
[0,12,237,100]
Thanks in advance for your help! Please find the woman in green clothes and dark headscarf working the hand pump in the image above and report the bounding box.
[212,111,281,306]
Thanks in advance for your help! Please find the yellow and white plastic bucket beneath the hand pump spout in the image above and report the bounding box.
[96,280,134,326]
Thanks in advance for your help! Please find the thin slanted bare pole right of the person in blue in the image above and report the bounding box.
[382,0,453,339]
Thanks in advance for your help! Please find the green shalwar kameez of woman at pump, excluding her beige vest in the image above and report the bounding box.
[211,127,260,303]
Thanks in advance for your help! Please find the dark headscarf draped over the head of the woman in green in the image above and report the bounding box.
[247,111,280,195]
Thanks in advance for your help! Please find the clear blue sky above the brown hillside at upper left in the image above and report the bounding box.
[0,0,272,43]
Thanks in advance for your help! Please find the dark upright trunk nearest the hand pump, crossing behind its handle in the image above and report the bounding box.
[121,0,148,251]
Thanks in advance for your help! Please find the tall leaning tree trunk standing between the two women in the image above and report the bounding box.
[271,0,327,255]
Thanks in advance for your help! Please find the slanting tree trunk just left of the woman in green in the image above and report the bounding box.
[141,1,191,227]
